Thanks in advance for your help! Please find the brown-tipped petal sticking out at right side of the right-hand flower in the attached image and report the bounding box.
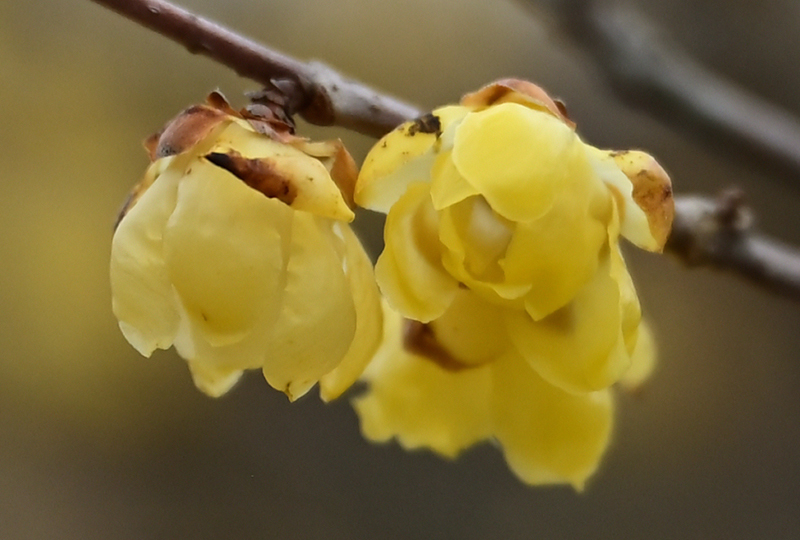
[611,150,675,251]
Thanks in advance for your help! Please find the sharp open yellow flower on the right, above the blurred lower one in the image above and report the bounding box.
[355,80,672,392]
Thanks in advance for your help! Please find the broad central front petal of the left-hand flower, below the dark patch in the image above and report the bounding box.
[164,161,293,346]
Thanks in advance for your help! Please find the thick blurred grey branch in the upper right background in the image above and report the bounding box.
[525,0,800,181]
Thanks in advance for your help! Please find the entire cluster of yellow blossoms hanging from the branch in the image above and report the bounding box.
[111,80,672,487]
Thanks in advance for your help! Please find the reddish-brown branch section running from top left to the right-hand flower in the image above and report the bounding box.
[92,0,419,137]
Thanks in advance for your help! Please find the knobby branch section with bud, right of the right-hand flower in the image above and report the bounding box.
[664,189,800,301]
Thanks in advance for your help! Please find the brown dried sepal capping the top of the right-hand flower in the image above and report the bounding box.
[461,79,575,128]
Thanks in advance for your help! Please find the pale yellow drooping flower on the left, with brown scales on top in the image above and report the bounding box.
[111,94,382,400]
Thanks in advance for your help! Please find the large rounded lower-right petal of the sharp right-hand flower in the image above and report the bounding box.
[507,255,630,392]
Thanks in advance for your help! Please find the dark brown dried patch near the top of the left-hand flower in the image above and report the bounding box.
[205,150,297,205]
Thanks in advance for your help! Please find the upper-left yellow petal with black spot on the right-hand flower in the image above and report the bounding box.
[355,106,469,213]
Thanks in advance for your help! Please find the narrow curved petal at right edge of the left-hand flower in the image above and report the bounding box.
[319,224,383,401]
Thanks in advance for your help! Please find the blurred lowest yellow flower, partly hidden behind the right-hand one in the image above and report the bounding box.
[354,300,613,489]
